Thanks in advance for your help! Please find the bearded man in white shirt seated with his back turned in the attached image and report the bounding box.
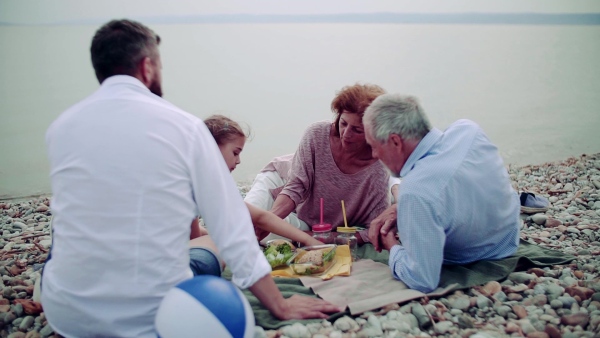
[41,20,340,337]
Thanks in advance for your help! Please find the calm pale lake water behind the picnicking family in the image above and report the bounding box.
[0,24,600,198]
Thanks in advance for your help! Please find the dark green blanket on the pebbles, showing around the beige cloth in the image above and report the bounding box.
[223,240,575,330]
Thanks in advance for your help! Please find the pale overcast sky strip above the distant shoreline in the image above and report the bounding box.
[0,0,600,24]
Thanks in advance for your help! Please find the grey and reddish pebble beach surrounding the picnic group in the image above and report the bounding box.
[0,153,600,338]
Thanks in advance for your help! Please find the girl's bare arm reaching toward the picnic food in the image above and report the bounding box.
[246,203,323,245]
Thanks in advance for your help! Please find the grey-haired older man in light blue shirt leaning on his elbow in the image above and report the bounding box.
[363,94,520,292]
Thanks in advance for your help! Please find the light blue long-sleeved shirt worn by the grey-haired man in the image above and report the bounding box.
[389,120,520,292]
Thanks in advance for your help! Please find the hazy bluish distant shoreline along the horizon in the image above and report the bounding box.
[0,13,600,26]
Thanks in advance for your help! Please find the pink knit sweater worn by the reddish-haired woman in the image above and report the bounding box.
[281,121,389,232]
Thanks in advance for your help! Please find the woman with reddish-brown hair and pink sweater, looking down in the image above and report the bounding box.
[245,84,399,244]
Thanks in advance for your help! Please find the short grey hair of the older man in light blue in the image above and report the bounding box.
[363,94,431,143]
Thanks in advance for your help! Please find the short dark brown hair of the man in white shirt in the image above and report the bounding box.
[90,19,160,83]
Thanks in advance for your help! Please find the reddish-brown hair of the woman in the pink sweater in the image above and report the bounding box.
[331,83,385,135]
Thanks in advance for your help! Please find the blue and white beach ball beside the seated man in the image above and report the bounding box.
[155,275,254,338]
